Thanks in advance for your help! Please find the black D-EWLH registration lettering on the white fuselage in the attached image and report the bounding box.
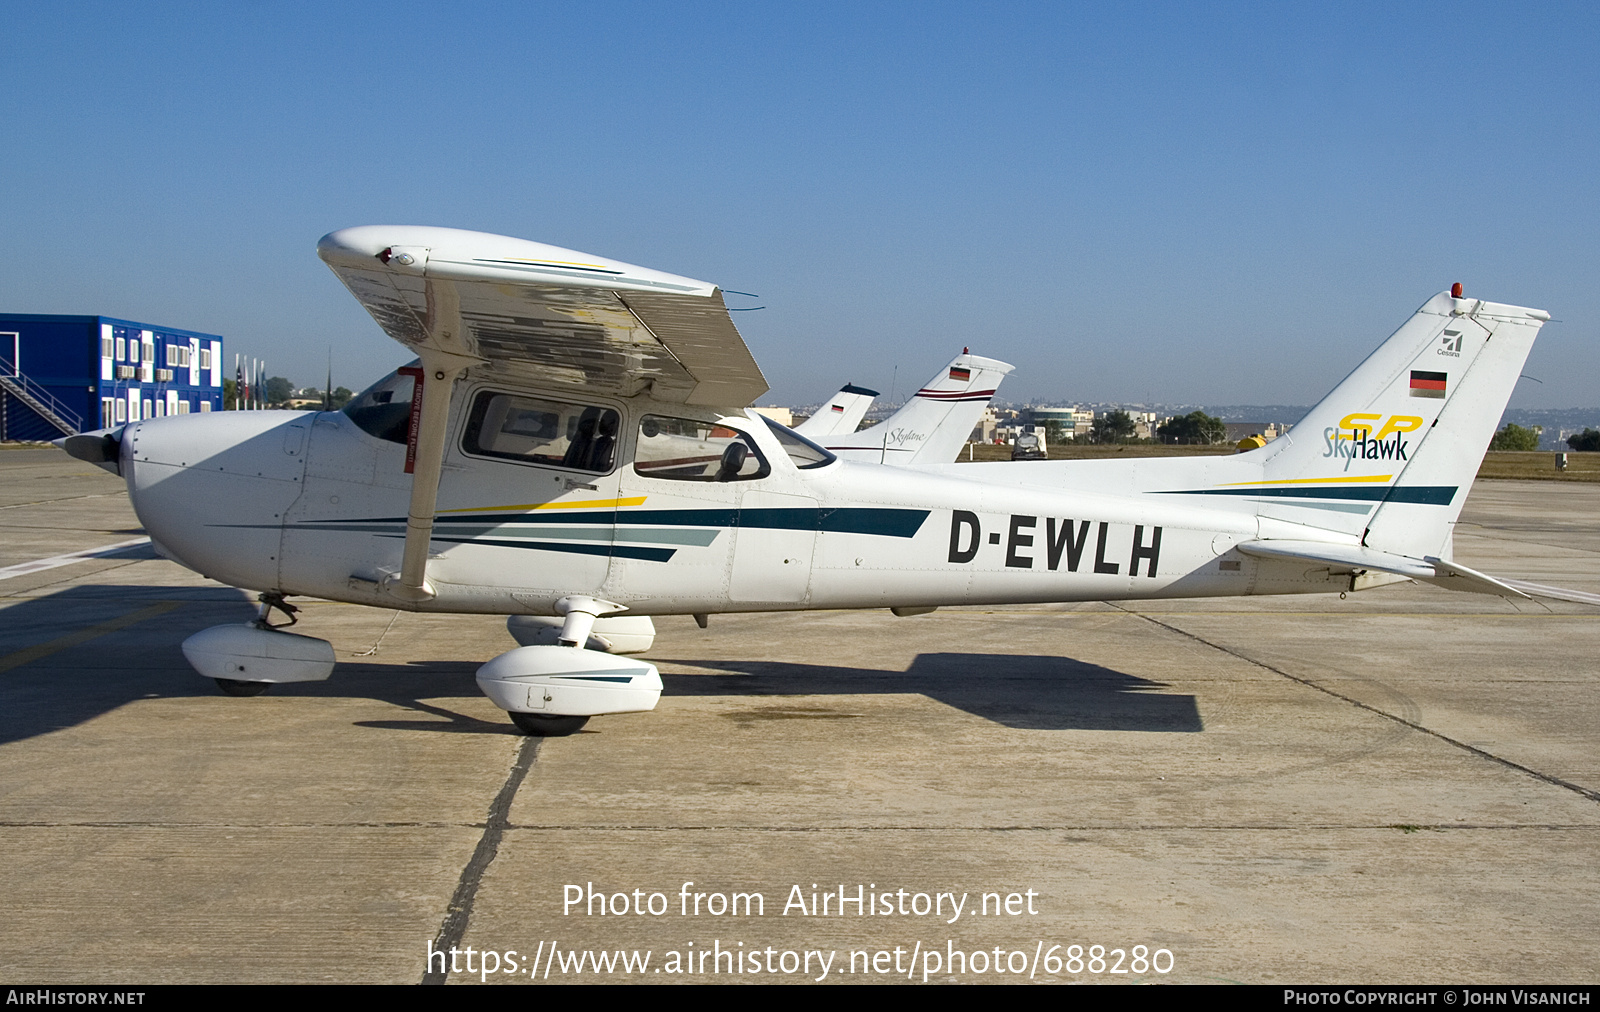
[950,509,1162,576]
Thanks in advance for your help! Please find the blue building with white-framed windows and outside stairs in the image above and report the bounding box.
[0,314,224,439]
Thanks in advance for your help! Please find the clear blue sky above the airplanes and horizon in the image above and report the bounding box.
[0,2,1600,407]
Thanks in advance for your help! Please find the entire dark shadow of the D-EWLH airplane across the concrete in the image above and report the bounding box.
[0,584,1202,745]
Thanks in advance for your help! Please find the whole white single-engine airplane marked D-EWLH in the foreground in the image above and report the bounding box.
[66,226,1549,735]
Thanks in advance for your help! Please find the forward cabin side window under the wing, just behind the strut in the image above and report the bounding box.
[462,391,622,474]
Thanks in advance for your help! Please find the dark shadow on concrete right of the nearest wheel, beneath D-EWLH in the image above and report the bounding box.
[661,653,1203,732]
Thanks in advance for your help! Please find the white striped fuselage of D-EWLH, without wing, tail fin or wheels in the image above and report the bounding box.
[122,378,1369,615]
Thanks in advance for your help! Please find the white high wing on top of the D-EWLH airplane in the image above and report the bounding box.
[317,226,766,410]
